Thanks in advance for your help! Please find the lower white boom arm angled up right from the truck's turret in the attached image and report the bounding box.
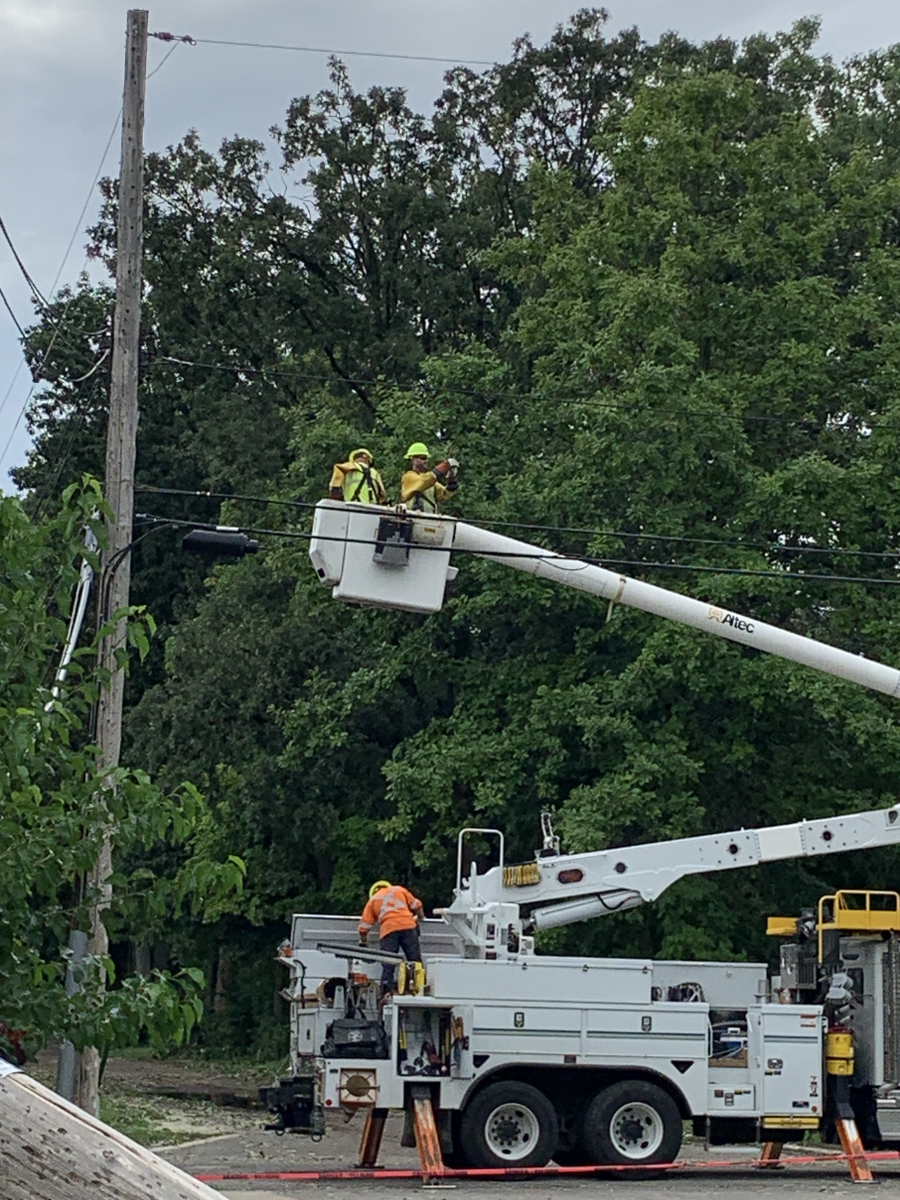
[449,804,900,929]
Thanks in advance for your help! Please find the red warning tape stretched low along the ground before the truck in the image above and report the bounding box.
[194,1150,900,1183]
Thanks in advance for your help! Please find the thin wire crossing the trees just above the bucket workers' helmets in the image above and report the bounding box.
[148,354,900,430]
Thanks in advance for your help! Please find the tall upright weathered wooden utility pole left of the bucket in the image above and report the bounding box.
[76,8,148,1116]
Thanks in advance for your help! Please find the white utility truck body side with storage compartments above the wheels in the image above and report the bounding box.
[286,931,823,1120]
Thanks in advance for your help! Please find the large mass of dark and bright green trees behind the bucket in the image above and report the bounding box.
[10,10,900,1046]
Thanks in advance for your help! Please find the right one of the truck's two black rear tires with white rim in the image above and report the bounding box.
[582,1079,682,1166]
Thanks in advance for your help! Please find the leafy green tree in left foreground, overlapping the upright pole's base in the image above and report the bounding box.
[0,480,244,1050]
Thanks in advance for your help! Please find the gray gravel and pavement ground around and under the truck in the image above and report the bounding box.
[24,1052,900,1200]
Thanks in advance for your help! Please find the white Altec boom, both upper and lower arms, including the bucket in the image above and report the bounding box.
[310,500,900,956]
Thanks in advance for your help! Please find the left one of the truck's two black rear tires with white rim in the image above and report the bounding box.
[460,1080,559,1166]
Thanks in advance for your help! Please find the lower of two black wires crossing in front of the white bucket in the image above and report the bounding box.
[134,512,900,587]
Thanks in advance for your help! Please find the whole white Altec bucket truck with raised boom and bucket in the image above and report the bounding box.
[260,500,900,1168]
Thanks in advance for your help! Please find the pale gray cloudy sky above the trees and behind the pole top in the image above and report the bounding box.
[0,0,900,491]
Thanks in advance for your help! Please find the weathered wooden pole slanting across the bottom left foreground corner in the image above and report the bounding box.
[0,1062,222,1200]
